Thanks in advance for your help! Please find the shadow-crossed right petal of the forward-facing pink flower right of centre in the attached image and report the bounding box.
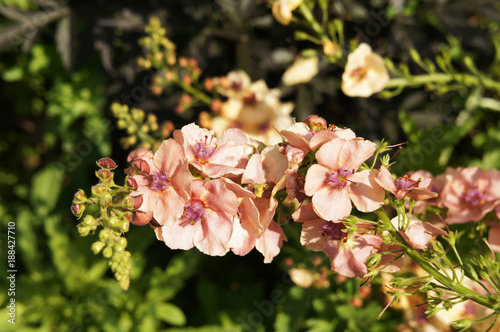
[348,170,385,212]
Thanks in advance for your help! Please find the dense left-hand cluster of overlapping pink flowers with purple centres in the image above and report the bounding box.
[127,124,287,262]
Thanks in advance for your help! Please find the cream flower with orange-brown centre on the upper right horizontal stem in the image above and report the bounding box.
[342,43,389,97]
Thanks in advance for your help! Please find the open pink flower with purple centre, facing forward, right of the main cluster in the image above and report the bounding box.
[304,138,385,221]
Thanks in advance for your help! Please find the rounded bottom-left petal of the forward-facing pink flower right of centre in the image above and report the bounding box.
[312,187,352,221]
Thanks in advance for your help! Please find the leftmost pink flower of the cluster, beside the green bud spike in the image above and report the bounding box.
[128,139,193,225]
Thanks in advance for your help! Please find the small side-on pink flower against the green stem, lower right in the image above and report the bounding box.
[391,216,448,249]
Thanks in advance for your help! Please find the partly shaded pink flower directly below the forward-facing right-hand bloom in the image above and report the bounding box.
[292,204,383,278]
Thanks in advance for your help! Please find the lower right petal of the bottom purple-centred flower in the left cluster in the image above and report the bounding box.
[194,209,233,256]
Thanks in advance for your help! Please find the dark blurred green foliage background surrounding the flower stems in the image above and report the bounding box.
[0,0,500,331]
